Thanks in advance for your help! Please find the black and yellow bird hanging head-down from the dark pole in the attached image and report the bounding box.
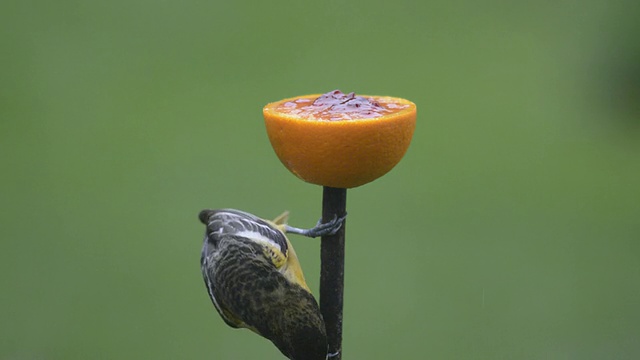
[199,209,344,360]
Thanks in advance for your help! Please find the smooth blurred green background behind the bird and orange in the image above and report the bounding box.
[0,0,640,360]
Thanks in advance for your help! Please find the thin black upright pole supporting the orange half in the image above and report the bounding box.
[320,186,347,360]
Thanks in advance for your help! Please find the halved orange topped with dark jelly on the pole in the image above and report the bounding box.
[263,90,416,188]
